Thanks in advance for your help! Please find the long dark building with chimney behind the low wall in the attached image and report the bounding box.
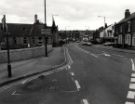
[0,15,58,49]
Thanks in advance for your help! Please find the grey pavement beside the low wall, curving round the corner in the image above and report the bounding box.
[0,47,65,86]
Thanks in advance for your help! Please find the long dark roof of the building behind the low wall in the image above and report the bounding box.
[0,23,51,37]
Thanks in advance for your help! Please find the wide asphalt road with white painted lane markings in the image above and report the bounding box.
[0,43,135,104]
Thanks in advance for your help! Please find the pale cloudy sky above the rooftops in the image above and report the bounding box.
[0,0,135,30]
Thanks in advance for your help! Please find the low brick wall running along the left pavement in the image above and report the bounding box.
[0,46,52,63]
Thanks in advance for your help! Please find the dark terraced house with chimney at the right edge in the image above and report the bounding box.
[115,9,135,47]
